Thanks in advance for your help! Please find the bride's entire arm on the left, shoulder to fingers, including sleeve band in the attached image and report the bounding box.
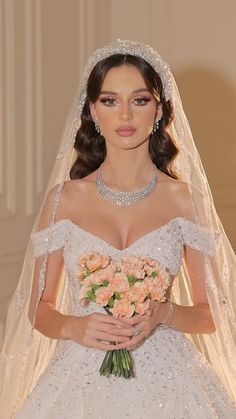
[28,185,130,350]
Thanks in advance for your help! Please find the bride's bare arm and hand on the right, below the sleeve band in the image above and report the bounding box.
[117,246,215,349]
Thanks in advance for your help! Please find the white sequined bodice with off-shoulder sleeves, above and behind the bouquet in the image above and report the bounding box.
[31,217,218,311]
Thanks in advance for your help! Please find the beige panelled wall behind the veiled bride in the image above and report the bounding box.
[0,0,236,334]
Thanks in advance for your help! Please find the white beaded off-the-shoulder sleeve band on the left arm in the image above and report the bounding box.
[30,220,68,256]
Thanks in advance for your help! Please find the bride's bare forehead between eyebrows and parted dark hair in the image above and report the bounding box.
[102,64,147,91]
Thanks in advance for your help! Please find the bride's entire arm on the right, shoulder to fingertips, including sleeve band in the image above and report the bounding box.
[117,183,216,349]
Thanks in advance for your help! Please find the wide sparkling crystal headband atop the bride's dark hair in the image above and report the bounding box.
[78,38,172,113]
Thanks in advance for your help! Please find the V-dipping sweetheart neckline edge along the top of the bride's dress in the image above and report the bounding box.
[43,216,193,253]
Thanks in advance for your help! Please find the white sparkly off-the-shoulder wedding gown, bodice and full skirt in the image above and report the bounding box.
[16,217,236,419]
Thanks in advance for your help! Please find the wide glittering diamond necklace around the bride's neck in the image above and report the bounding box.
[96,166,158,207]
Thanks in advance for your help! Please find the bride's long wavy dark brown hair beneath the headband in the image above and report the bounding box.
[70,54,179,179]
